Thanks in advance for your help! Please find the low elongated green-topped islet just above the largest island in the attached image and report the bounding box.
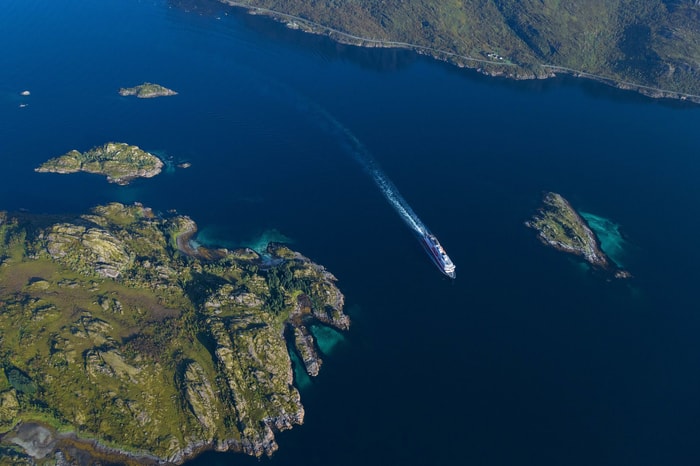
[35,142,163,186]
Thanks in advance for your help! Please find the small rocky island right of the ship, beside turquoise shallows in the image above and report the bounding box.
[525,192,631,278]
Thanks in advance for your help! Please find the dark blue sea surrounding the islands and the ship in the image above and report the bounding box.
[0,0,700,466]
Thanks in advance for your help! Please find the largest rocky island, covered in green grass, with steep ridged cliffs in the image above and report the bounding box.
[0,203,350,464]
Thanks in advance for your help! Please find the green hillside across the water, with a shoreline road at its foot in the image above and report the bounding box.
[228,0,700,100]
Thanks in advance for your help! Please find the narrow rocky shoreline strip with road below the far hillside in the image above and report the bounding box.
[219,0,700,104]
